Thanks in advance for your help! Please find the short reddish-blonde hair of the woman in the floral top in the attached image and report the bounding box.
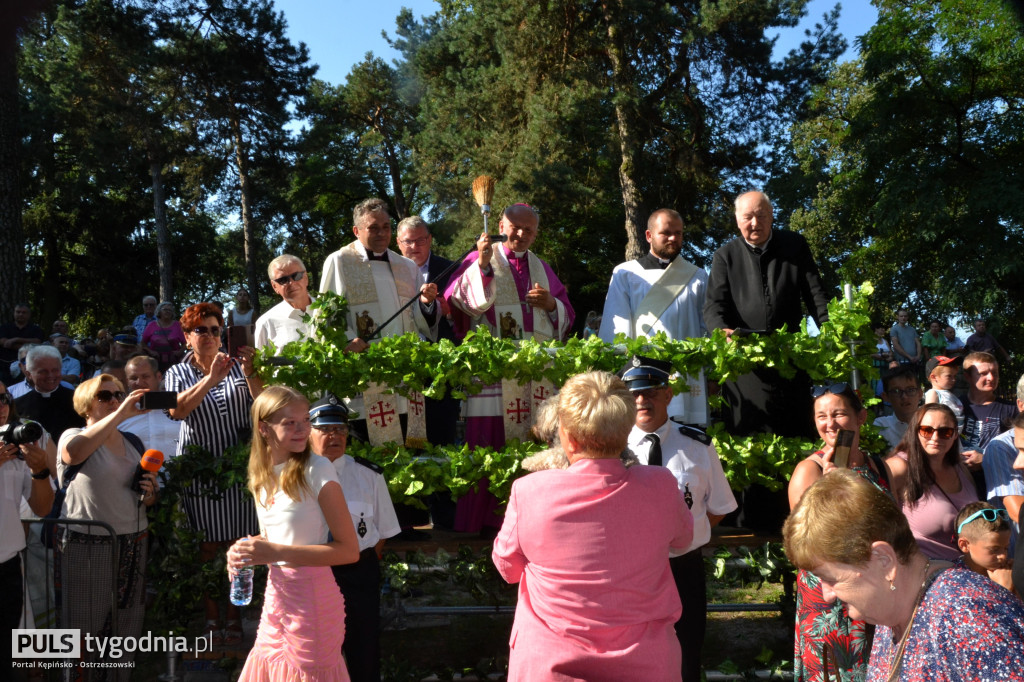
[782,469,918,570]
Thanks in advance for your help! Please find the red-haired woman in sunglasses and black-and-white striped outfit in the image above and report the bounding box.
[164,303,263,644]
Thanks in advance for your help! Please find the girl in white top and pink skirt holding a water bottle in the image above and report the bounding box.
[227,386,359,682]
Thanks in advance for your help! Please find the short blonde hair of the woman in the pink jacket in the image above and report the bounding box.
[558,372,637,458]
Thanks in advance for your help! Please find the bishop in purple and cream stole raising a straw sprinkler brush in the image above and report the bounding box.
[444,204,575,530]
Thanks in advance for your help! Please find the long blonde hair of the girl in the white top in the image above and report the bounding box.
[249,386,312,504]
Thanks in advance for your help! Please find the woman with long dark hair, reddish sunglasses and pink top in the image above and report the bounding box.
[886,402,978,561]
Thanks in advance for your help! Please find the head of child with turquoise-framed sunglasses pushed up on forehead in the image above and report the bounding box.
[956,502,1014,592]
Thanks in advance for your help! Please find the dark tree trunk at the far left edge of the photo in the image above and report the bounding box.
[0,12,25,315]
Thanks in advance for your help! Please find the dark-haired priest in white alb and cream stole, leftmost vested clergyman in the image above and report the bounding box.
[319,199,439,445]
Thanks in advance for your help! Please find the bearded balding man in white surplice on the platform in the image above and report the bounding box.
[598,209,708,425]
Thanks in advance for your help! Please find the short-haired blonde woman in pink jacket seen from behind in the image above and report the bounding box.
[493,372,693,682]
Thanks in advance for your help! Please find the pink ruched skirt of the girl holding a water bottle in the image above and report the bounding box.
[239,566,348,682]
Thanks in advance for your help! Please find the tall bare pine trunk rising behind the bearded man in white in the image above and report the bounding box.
[601,2,648,260]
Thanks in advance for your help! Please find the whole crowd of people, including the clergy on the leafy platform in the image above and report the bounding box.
[0,191,1024,682]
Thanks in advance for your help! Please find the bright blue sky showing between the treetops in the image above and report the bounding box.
[274,0,878,84]
